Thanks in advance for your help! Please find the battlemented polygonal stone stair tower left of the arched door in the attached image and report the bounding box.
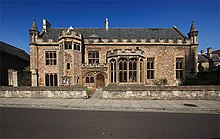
[58,26,82,86]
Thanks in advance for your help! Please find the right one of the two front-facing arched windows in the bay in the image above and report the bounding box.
[129,59,137,82]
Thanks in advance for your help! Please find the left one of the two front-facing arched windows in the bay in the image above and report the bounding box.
[119,58,127,82]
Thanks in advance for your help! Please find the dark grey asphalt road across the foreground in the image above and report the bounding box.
[0,108,220,138]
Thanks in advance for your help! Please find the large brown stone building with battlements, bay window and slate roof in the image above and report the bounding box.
[29,19,198,88]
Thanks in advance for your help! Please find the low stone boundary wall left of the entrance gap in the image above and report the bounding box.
[0,85,88,98]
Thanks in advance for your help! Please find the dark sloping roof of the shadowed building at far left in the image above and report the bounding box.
[0,41,30,61]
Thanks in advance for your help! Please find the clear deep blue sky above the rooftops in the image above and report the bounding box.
[0,0,220,53]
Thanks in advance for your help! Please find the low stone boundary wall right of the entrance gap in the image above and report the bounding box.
[102,85,220,100]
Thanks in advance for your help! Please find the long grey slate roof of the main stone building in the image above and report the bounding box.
[42,27,186,41]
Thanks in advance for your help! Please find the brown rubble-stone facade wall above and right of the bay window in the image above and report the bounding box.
[85,43,195,86]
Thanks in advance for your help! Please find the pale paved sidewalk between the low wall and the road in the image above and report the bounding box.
[0,98,220,114]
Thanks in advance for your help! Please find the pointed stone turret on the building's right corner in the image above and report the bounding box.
[188,21,198,44]
